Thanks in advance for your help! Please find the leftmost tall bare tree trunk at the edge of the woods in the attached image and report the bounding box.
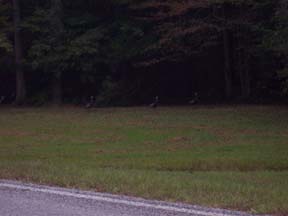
[13,0,26,105]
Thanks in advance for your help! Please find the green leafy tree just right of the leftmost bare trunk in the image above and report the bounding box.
[25,0,106,104]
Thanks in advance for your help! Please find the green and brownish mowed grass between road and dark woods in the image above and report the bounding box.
[0,106,288,215]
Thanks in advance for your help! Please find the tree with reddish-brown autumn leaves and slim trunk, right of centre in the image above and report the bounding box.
[130,0,251,99]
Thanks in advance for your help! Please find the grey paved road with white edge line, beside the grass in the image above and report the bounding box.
[0,180,256,216]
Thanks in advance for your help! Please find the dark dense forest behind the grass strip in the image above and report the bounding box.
[0,0,288,106]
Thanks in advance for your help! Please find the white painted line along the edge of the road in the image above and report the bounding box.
[0,183,231,216]
